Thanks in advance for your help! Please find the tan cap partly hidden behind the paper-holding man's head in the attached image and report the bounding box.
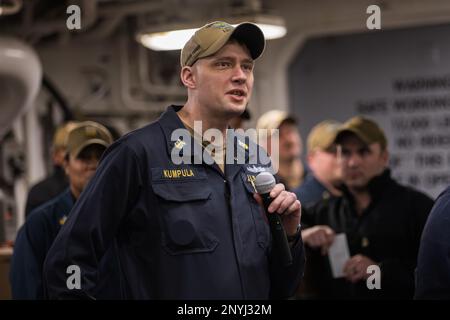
[307,120,342,152]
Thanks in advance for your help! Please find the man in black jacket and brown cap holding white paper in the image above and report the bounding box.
[302,117,433,299]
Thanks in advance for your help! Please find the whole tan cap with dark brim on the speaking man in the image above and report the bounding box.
[180,21,266,67]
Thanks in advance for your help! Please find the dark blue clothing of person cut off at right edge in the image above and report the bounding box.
[414,187,450,299]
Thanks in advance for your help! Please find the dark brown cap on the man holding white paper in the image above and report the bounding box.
[336,116,387,149]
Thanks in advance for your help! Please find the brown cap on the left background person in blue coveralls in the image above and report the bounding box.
[67,121,113,158]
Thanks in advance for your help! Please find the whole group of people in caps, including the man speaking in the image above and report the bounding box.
[10,22,450,299]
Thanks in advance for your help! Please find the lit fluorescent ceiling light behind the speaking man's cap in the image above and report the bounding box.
[136,17,286,51]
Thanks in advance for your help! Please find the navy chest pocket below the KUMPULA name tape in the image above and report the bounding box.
[152,169,218,255]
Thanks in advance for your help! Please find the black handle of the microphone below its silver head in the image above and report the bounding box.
[261,193,292,267]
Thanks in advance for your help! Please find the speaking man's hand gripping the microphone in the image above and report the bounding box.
[253,183,302,236]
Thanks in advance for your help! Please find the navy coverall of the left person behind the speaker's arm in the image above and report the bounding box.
[10,188,121,300]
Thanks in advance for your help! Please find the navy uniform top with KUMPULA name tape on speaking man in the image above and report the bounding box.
[44,106,304,299]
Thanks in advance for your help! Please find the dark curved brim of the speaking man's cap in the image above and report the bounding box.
[232,22,266,60]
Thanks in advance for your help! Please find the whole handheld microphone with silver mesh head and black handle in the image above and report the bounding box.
[255,172,292,266]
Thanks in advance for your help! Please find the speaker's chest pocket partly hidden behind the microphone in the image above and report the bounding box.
[241,172,271,252]
